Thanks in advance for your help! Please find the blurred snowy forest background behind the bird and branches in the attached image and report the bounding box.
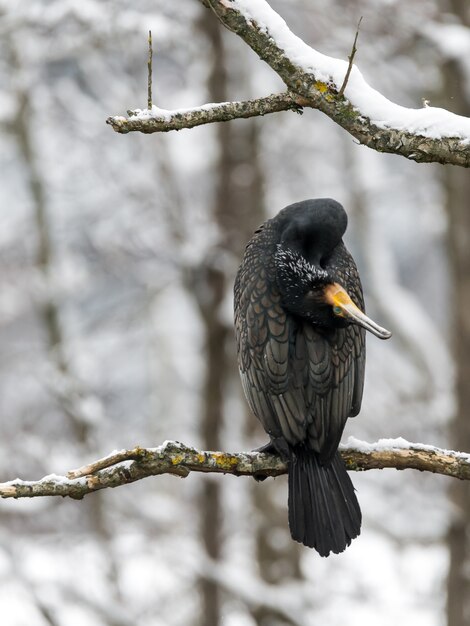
[0,0,470,626]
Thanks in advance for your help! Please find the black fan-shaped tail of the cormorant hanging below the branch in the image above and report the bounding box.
[289,446,362,556]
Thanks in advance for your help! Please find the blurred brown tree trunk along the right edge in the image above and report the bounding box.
[442,0,470,626]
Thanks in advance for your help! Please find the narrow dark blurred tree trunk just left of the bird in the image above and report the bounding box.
[191,16,234,626]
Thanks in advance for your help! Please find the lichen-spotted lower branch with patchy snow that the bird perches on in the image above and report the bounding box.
[0,437,470,500]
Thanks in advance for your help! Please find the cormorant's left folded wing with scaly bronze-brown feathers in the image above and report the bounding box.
[235,238,307,452]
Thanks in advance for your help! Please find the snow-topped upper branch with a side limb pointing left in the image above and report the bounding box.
[107,0,470,167]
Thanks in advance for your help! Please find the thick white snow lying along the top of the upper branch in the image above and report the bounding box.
[230,0,470,142]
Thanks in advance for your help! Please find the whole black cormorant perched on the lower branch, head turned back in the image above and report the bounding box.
[235,198,391,556]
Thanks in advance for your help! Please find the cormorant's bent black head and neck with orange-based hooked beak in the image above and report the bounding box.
[275,199,391,339]
